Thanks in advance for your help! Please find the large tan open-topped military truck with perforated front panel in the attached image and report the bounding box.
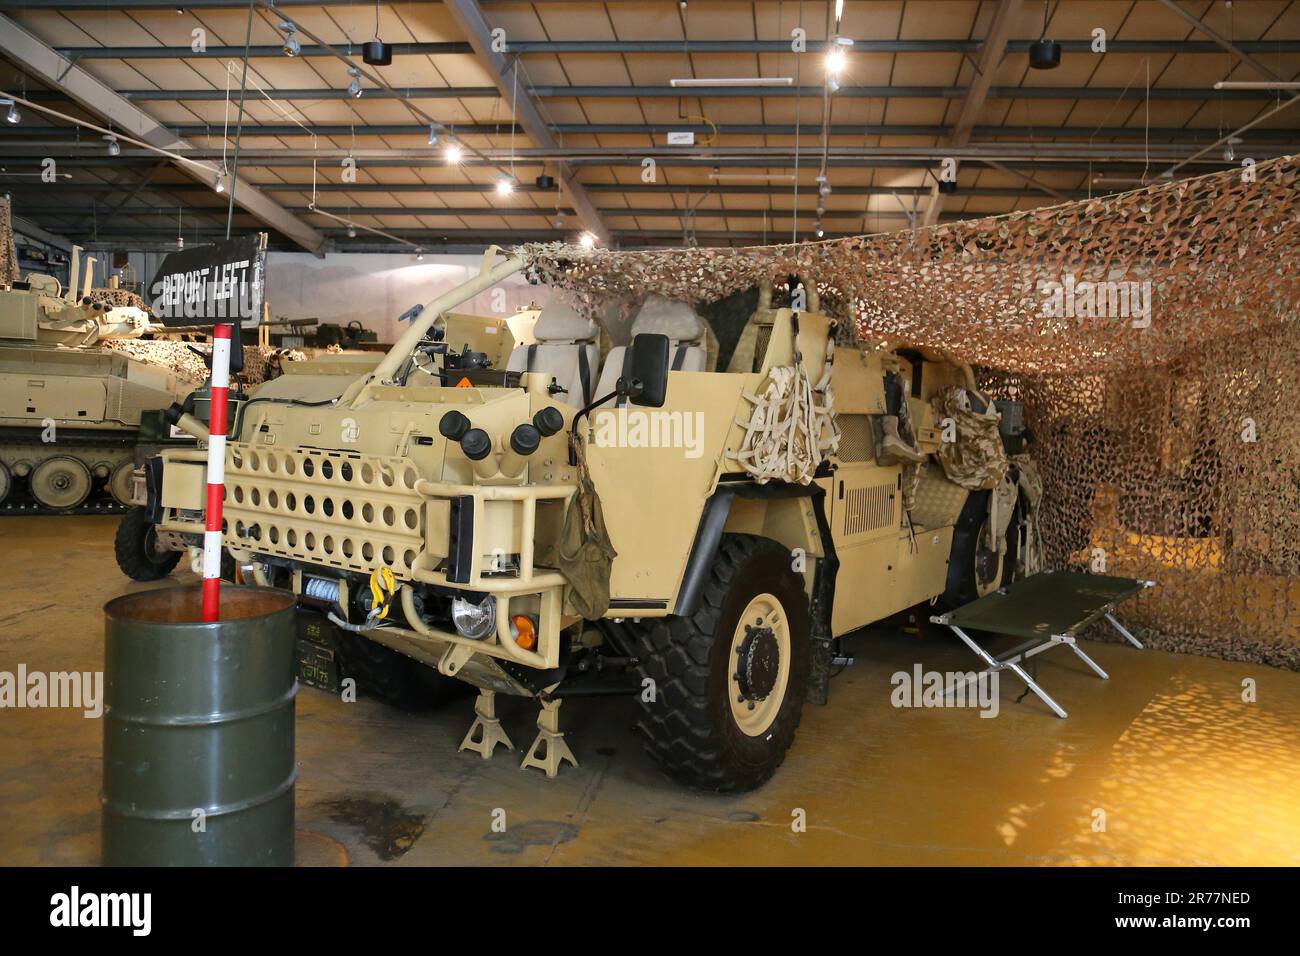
[139,248,1032,790]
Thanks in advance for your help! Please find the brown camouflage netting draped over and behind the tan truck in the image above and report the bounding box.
[523,157,1300,669]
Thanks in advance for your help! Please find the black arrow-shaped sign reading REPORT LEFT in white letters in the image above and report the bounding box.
[150,233,267,325]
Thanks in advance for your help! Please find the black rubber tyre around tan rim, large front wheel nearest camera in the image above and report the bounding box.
[638,535,811,791]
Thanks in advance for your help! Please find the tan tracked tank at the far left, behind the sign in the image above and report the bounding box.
[0,247,198,511]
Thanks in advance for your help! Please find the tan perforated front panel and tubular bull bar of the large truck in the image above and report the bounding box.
[160,442,575,669]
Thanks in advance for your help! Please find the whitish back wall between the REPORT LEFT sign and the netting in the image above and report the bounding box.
[267,252,550,342]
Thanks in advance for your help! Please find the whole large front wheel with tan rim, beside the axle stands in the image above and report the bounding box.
[640,535,810,791]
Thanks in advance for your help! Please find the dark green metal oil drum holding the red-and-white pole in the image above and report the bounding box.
[100,585,298,866]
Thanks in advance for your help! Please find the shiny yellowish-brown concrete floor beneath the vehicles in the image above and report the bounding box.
[0,518,1300,865]
